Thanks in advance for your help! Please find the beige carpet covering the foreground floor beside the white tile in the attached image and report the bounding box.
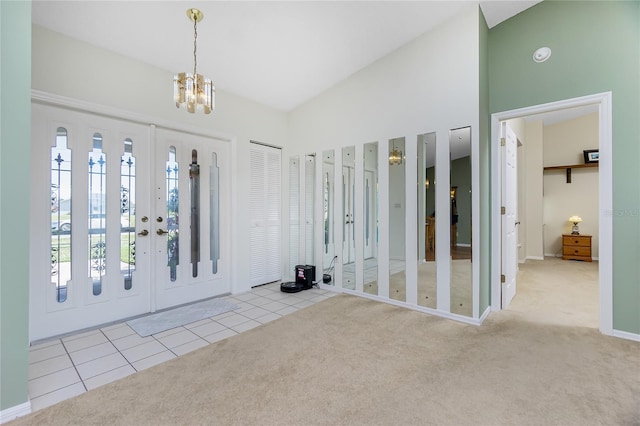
[10,262,640,425]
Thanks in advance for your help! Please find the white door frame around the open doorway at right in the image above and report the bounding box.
[491,92,613,335]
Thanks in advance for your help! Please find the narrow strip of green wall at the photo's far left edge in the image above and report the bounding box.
[0,0,31,410]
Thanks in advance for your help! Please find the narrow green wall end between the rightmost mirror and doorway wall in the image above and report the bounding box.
[477,6,491,315]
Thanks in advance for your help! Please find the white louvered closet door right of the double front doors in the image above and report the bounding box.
[249,143,282,287]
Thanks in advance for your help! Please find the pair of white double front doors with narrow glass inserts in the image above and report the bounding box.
[29,103,230,341]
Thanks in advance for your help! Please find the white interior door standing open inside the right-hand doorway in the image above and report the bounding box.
[501,123,518,309]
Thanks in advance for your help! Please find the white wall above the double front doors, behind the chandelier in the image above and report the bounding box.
[32,25,288,291]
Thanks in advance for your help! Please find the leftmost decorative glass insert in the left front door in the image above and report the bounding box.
[51,127,71,303]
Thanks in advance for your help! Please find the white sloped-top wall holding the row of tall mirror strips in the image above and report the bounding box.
[289,6,480,310]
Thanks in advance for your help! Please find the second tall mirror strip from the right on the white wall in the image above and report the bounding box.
[417,133,437,309]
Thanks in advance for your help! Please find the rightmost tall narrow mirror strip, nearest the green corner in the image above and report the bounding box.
[449,127,473,316]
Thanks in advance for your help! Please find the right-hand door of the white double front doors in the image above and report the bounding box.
[154,129,231,309]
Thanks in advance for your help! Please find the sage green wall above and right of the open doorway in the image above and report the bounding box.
[489,0,640,333]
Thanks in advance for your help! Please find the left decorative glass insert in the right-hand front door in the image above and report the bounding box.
[166,146,180,281]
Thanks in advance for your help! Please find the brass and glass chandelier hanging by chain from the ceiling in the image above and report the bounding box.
[173,8,215,114]
